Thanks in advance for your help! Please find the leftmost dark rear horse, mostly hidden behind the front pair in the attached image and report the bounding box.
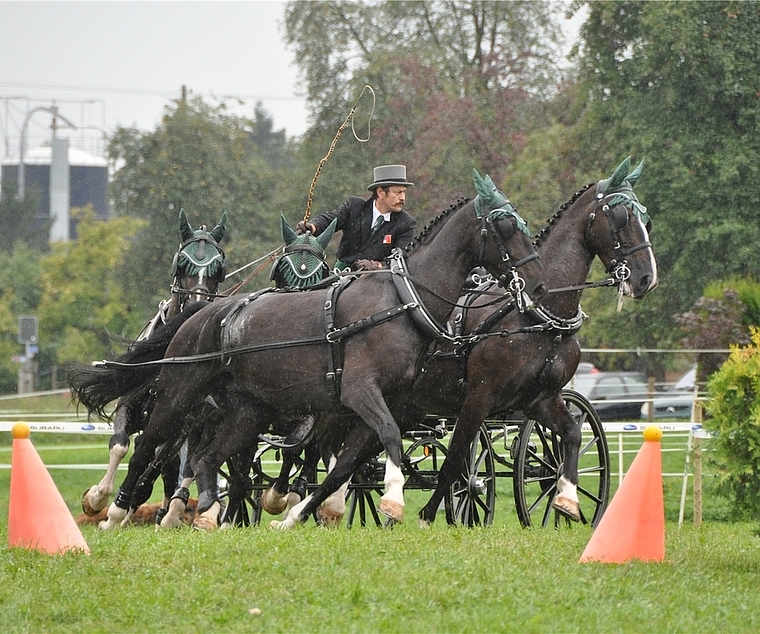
[82,209,227,516]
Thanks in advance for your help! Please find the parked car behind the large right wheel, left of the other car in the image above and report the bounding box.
[567,372,649,421]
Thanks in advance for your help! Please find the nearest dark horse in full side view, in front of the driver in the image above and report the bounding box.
[74,173,545,528]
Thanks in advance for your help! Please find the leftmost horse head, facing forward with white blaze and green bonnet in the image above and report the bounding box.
[172,209,227,310]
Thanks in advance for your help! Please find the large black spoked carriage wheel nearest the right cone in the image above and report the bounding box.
[512,390,610,528]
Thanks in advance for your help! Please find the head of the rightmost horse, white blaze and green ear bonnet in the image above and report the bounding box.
[585,156,658,299]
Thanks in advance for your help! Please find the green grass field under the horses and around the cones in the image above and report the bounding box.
[0,388,760,632]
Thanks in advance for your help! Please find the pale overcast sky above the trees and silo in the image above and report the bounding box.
[0,0,306,158]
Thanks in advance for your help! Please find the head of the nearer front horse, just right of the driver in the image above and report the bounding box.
[472,169,546,310]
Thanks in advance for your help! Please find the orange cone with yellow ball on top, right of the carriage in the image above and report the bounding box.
[579,425,665,564]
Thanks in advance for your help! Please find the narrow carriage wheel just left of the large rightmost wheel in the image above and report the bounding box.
[444,426,496,527]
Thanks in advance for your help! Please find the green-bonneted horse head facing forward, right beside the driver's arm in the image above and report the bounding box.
[270,214,337,288]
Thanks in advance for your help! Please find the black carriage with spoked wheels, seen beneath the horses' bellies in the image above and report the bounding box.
[220,389,610,528]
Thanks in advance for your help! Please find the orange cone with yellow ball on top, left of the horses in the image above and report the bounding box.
[8,423,90,555]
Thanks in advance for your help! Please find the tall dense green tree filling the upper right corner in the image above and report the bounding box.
[574,1,760,347]
